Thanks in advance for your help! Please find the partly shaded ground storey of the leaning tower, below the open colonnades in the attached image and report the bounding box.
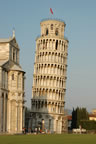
[29,112,67,134]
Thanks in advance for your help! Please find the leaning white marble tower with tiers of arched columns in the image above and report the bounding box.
[31,19,68,133]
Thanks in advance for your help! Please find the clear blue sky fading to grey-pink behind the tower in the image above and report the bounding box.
[0,0,96,111]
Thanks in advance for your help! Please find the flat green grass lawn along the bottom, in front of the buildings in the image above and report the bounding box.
[0,134,96,144]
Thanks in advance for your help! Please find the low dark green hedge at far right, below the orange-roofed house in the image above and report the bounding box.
[80,120,96,130]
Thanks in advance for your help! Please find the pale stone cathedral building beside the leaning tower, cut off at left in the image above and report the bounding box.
[0,31,25,133]
